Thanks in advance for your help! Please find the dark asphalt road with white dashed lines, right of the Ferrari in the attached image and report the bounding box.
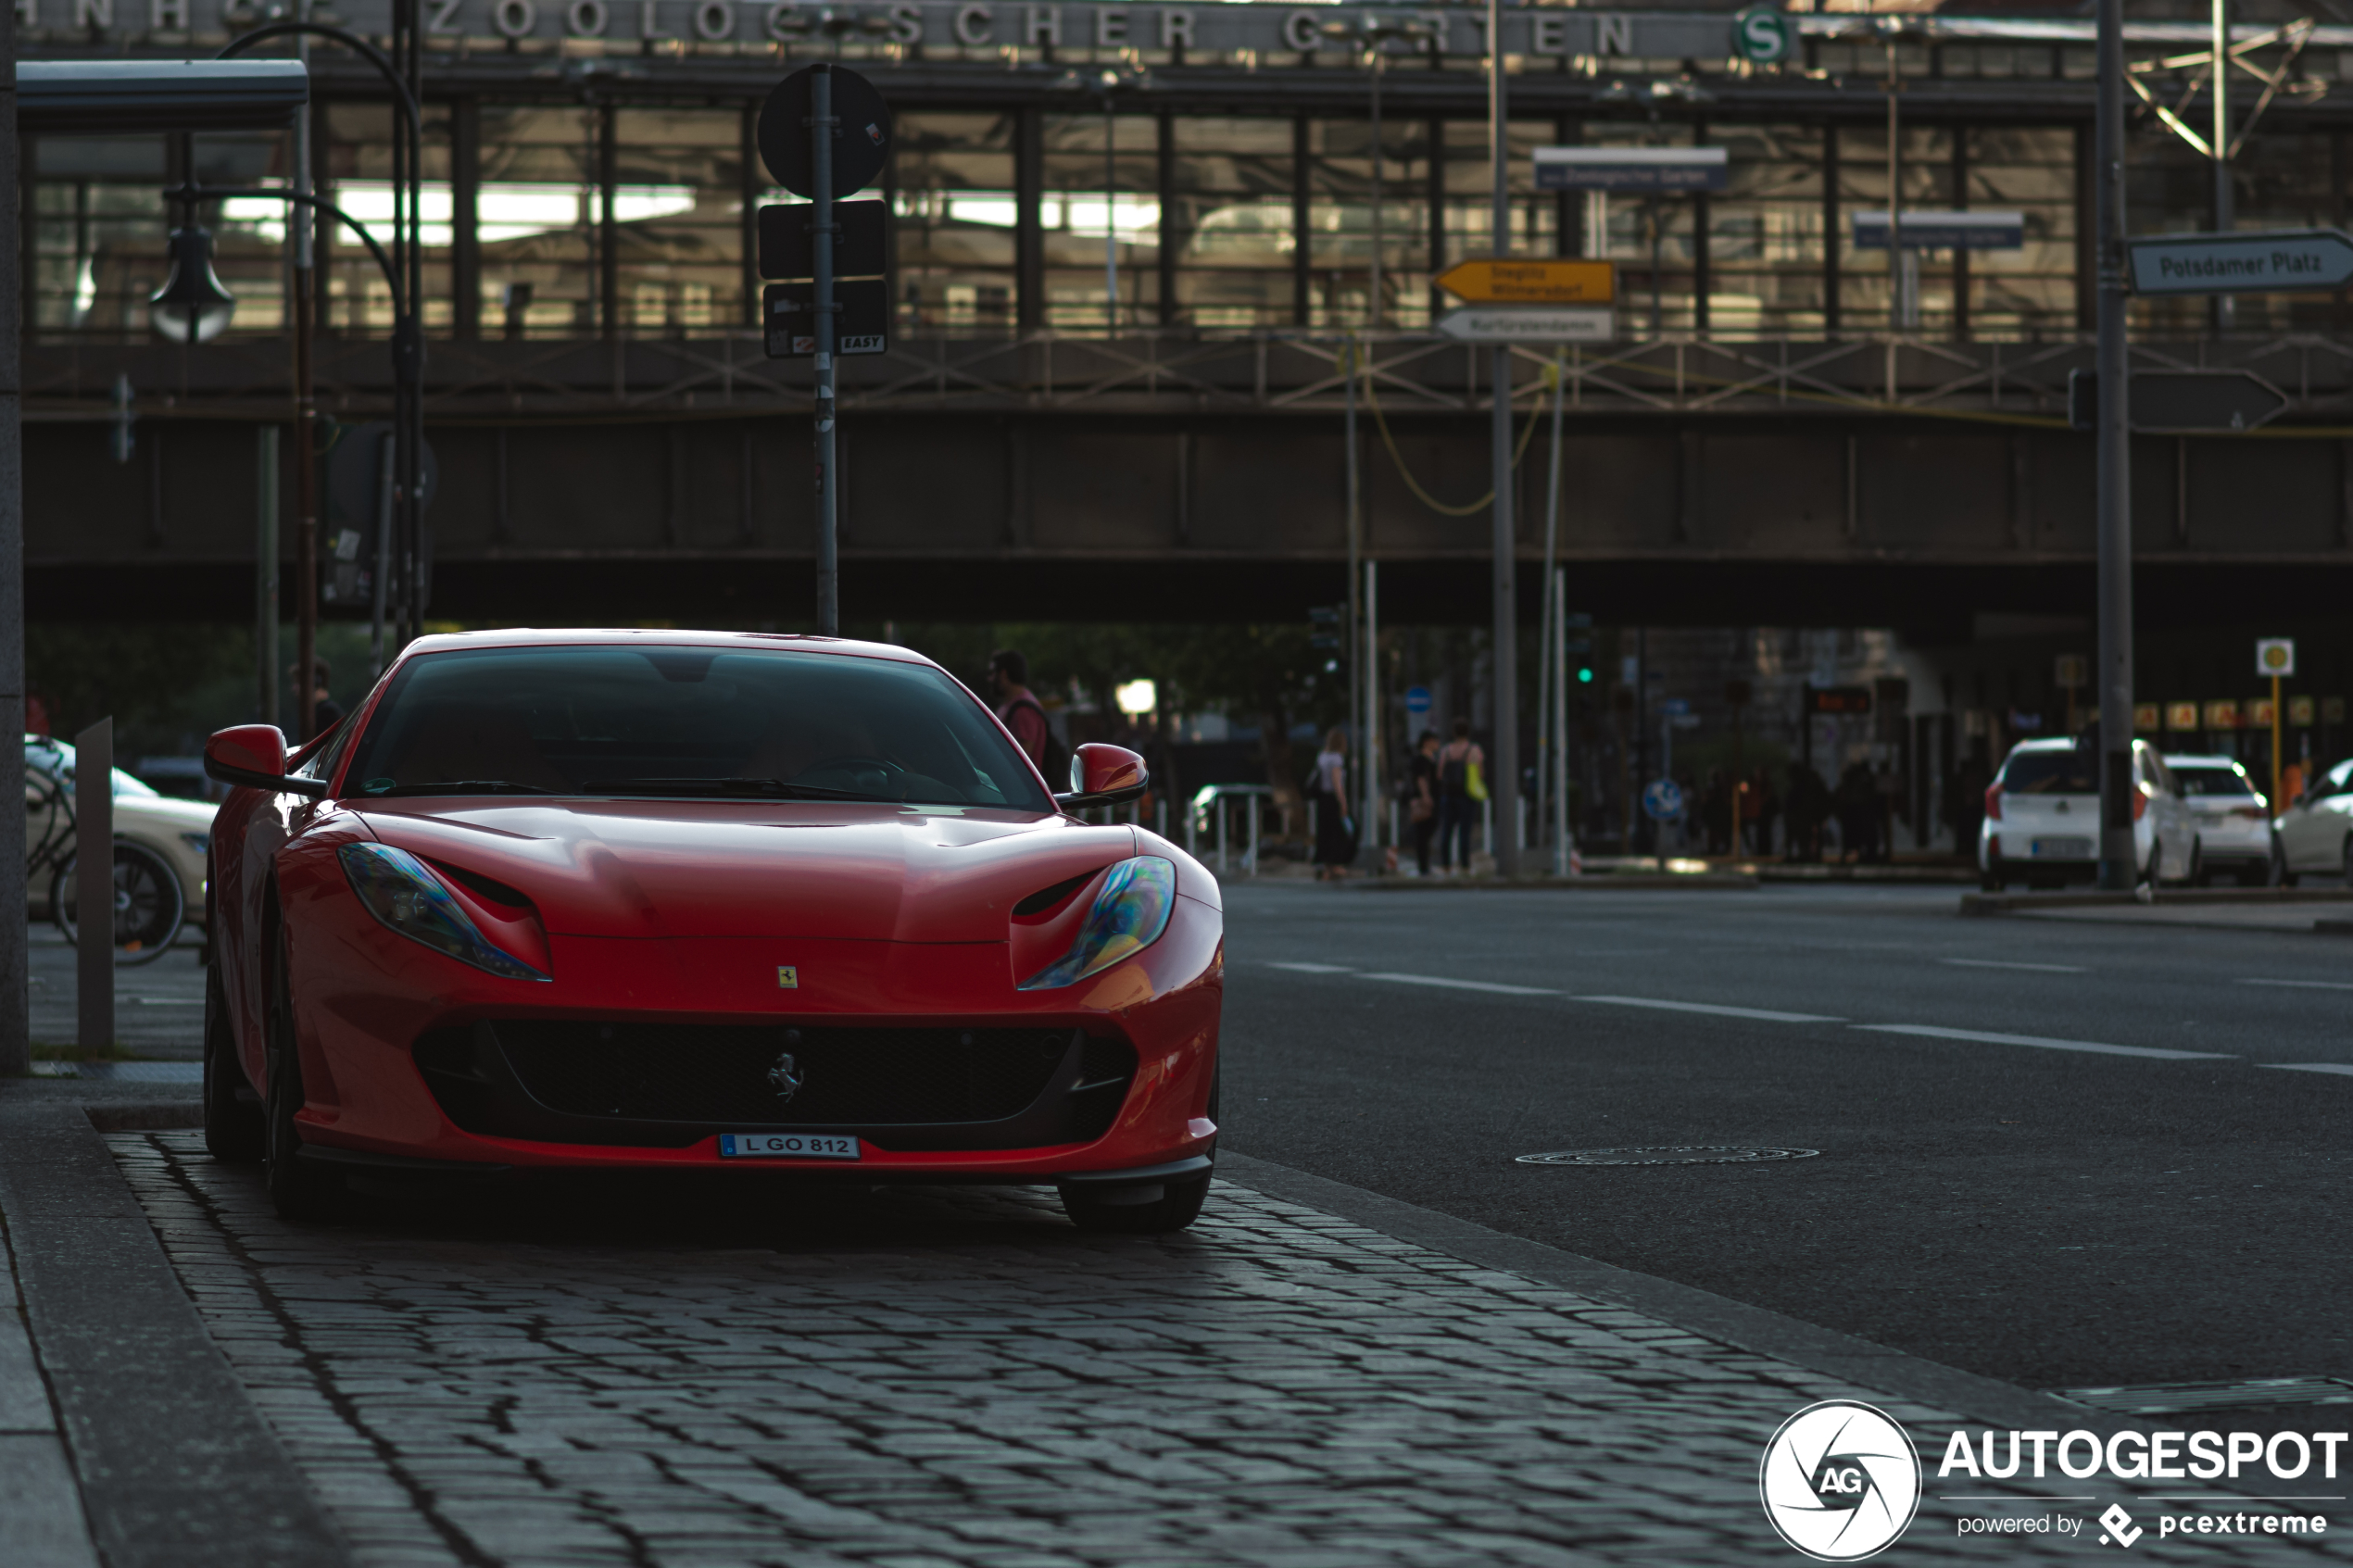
[1224,884,2353,1429]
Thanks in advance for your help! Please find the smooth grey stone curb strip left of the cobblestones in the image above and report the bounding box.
[0,1102,350,1568]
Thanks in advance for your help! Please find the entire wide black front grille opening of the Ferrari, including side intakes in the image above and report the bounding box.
[417,1018,1137,1149]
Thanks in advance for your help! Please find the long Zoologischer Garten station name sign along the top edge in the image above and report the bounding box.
[17,0,1757,64]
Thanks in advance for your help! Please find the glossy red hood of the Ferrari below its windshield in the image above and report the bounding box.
[346,797,1137,943]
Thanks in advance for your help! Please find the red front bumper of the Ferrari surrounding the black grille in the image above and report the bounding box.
[287,898,1224,1180]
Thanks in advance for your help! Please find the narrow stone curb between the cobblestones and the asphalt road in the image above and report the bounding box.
[1216,1148,2125,1432]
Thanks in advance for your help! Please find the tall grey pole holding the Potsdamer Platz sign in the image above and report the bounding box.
[2095,0,2141,891]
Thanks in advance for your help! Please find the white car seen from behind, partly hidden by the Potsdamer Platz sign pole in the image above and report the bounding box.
[1977,741,2202,894]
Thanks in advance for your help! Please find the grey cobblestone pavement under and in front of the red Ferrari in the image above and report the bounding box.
[108,1133,2334,1568]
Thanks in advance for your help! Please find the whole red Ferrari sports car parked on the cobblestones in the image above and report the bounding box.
[205,630,1224,1232]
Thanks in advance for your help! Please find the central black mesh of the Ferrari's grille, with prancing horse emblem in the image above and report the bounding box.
[497,1021,1071,1126]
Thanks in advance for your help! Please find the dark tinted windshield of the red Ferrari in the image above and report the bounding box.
[344,646,1054,811]
